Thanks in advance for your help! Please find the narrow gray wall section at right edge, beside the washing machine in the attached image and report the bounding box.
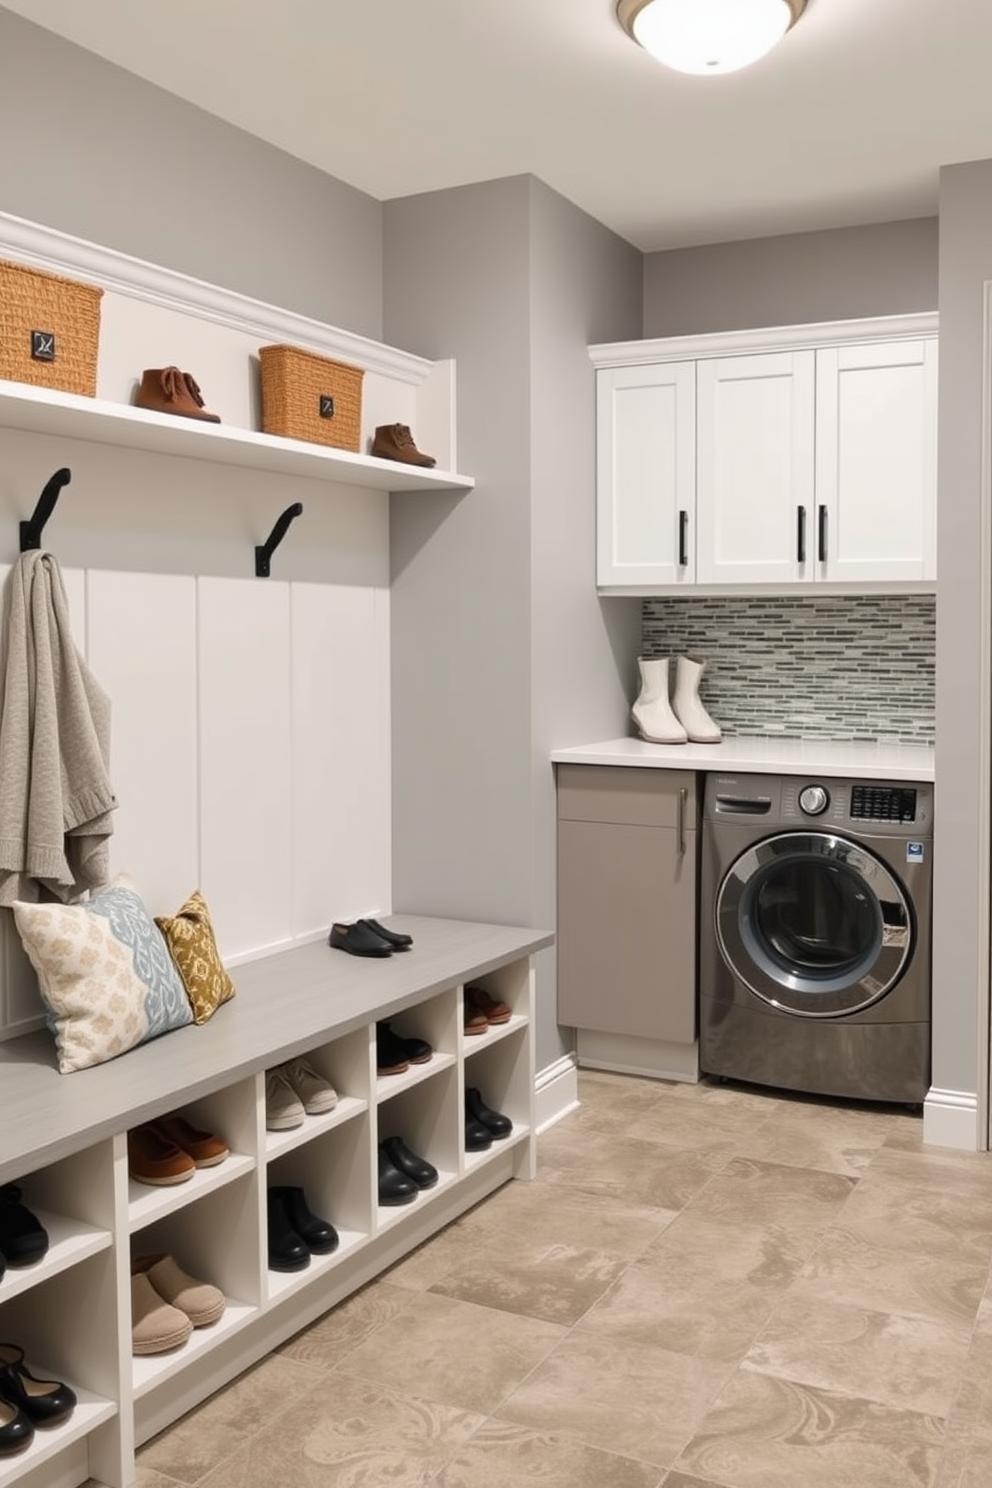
[934,161,992,1113]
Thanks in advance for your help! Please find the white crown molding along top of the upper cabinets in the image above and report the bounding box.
[589,311,938,368]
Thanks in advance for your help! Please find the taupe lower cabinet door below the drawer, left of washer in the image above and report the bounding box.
[558,821,696,1043]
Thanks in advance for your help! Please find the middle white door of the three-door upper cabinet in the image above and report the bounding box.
[696,351,815,583]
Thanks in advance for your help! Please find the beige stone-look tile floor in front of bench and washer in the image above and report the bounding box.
[131,1071,992,1488]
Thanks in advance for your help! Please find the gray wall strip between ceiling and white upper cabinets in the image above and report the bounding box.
[644,217,937,336]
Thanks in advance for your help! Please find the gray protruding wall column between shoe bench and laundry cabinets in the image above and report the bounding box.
[384,177,641,1067]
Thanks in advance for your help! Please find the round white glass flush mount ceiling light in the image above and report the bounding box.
[617,0,806,73]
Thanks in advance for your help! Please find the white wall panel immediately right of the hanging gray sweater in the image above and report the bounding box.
[88,570,199,914]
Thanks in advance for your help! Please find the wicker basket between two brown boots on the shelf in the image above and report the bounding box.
[259,347,364,451]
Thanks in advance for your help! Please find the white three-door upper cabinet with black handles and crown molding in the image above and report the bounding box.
[590,315,937,592]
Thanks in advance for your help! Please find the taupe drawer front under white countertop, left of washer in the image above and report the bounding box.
[558,765,696,832]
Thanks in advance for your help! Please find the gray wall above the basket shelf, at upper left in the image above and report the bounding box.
[0,10,382,339]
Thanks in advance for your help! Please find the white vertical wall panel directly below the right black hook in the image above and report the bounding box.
[198,577,294,957]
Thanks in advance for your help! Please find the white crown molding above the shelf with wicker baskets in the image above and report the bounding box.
[0,211,433,385]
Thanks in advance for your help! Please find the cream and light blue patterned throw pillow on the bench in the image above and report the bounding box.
[13,876,193,1074]
